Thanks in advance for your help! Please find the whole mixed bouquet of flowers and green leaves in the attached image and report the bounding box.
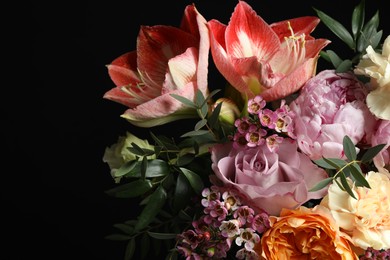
[103,0,390,259]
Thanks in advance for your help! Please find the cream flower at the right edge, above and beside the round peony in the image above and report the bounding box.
[354,35,390,120]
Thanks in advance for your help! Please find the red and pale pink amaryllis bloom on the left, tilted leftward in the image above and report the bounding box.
[104,5,210,127]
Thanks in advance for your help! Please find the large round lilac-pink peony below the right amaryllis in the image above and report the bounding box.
[290,70,376,160]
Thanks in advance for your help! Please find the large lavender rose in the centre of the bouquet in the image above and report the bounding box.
[211,139,328,216]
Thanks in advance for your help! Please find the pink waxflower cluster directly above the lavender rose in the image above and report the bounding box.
[233,95,295,152]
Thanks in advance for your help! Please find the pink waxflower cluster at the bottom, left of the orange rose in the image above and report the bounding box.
[177,186,270,260]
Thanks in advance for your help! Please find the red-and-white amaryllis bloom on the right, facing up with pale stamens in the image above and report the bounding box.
[208,1,330,101]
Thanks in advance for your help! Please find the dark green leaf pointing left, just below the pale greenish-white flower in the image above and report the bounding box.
[106,179,153,198]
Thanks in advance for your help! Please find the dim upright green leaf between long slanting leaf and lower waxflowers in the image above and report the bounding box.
[173,174,194,212]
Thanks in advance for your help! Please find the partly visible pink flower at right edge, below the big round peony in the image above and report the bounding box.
[371,120,390,172]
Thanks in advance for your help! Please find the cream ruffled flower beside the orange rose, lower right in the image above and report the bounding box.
[321,171,390,250]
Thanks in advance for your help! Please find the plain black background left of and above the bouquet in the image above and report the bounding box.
[5,0,389,260]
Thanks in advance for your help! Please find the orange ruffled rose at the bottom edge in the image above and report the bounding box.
[257,206,358,260]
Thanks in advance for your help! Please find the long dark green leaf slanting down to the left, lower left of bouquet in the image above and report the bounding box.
[135,185,167,231]
